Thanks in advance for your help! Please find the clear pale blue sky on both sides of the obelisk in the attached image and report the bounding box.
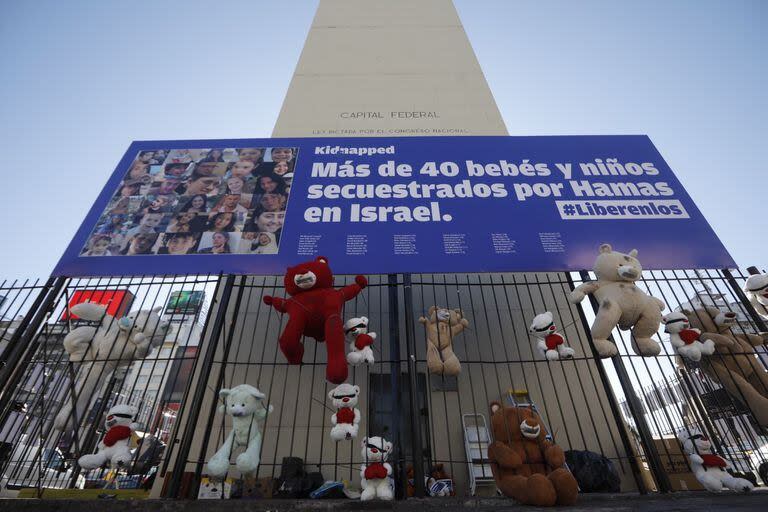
[0,0,768,279]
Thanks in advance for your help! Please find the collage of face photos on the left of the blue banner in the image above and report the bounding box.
[80,147,297,256]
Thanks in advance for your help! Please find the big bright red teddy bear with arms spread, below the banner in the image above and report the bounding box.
[264,256,368,384]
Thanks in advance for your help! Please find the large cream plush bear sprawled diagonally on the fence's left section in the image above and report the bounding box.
[53,302,170,430]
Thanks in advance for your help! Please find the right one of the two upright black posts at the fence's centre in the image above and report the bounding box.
[403,274,425,498]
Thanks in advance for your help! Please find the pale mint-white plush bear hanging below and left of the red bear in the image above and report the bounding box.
[207,384,273,479]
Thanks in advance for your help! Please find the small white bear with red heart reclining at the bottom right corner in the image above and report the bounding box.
[677,430,754,492]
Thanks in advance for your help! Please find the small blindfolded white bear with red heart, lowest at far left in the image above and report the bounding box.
[77,406,138,471]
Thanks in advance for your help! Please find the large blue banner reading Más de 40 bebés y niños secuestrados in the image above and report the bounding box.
[54,136,735,276]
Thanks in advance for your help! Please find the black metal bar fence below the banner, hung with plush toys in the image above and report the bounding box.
[0,270,768,498]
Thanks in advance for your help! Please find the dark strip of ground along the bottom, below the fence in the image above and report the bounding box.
[0,490,768,512]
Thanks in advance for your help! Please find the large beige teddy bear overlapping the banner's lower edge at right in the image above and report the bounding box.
[570,244,666,357]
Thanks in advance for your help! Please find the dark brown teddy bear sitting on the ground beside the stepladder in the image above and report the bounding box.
[488,402,579,507]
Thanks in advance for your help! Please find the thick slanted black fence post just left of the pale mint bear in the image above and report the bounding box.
[164,274,235,498]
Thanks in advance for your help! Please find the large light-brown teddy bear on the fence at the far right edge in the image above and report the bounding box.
[683,306,768,427]
